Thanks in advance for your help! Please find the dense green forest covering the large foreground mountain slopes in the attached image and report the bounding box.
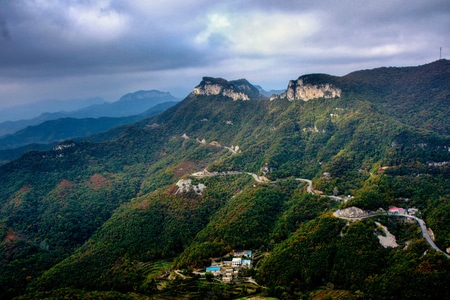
[0,60,450,299]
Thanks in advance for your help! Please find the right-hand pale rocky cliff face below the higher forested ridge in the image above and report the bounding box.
[270,78,341,101]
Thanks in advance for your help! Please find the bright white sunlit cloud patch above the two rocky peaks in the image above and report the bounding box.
[195,12,320,55]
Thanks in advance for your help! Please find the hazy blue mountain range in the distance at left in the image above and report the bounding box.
[0,90,179,162]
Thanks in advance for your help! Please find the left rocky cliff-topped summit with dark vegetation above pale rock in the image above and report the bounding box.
[192,77,264,101]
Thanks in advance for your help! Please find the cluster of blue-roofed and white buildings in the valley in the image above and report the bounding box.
[206,250,252,283]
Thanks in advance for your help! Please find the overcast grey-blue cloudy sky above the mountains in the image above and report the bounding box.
[0,0,450,109]
